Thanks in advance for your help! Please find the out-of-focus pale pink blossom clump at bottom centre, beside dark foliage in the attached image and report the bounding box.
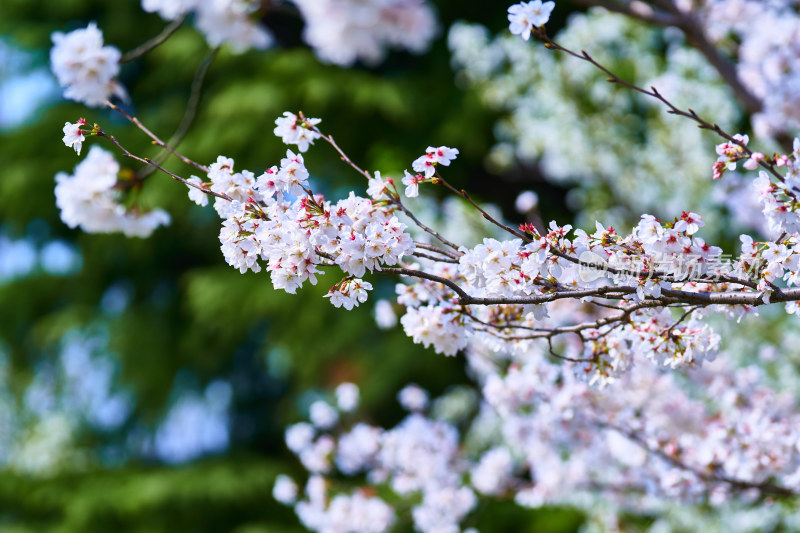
[273,384,478,533]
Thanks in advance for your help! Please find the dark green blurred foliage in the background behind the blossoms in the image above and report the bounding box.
[0,0,581,533]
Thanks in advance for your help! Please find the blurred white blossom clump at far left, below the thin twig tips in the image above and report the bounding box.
[55,145,170,237]
